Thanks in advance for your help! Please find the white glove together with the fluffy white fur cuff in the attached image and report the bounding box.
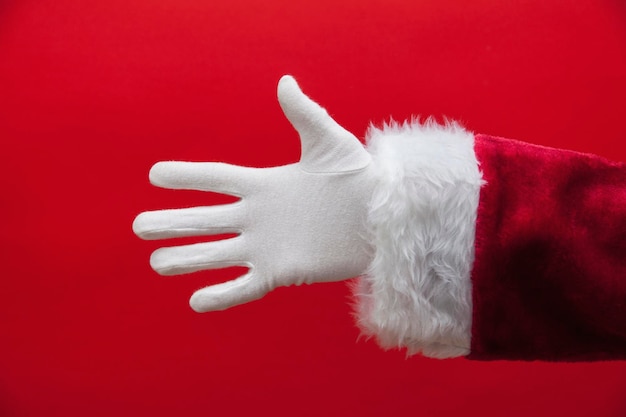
[133,76,480,357]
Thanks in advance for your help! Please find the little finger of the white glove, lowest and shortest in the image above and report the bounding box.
[189,272,269,313]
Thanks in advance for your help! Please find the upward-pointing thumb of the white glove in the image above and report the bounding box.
[278,75,370,172]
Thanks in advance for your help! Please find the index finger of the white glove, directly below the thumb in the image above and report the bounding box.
[150,161,259,196]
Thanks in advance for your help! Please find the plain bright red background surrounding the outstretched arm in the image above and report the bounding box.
[0,0,626,417]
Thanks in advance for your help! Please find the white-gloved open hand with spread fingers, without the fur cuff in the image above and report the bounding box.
[133,76,375,312]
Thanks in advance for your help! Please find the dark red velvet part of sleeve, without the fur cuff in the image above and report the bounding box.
[469,135,626,361]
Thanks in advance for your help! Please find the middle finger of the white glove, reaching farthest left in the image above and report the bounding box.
[133,202,243,240]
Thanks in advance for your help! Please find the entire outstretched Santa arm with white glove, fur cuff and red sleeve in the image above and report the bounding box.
[133,76,626,360]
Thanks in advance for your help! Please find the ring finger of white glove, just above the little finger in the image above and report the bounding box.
[150,237,247,275]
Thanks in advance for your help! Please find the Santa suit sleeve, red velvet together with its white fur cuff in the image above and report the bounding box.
[354,123,626,361]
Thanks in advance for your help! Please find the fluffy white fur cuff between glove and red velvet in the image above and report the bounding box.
[354,120,482,358]
